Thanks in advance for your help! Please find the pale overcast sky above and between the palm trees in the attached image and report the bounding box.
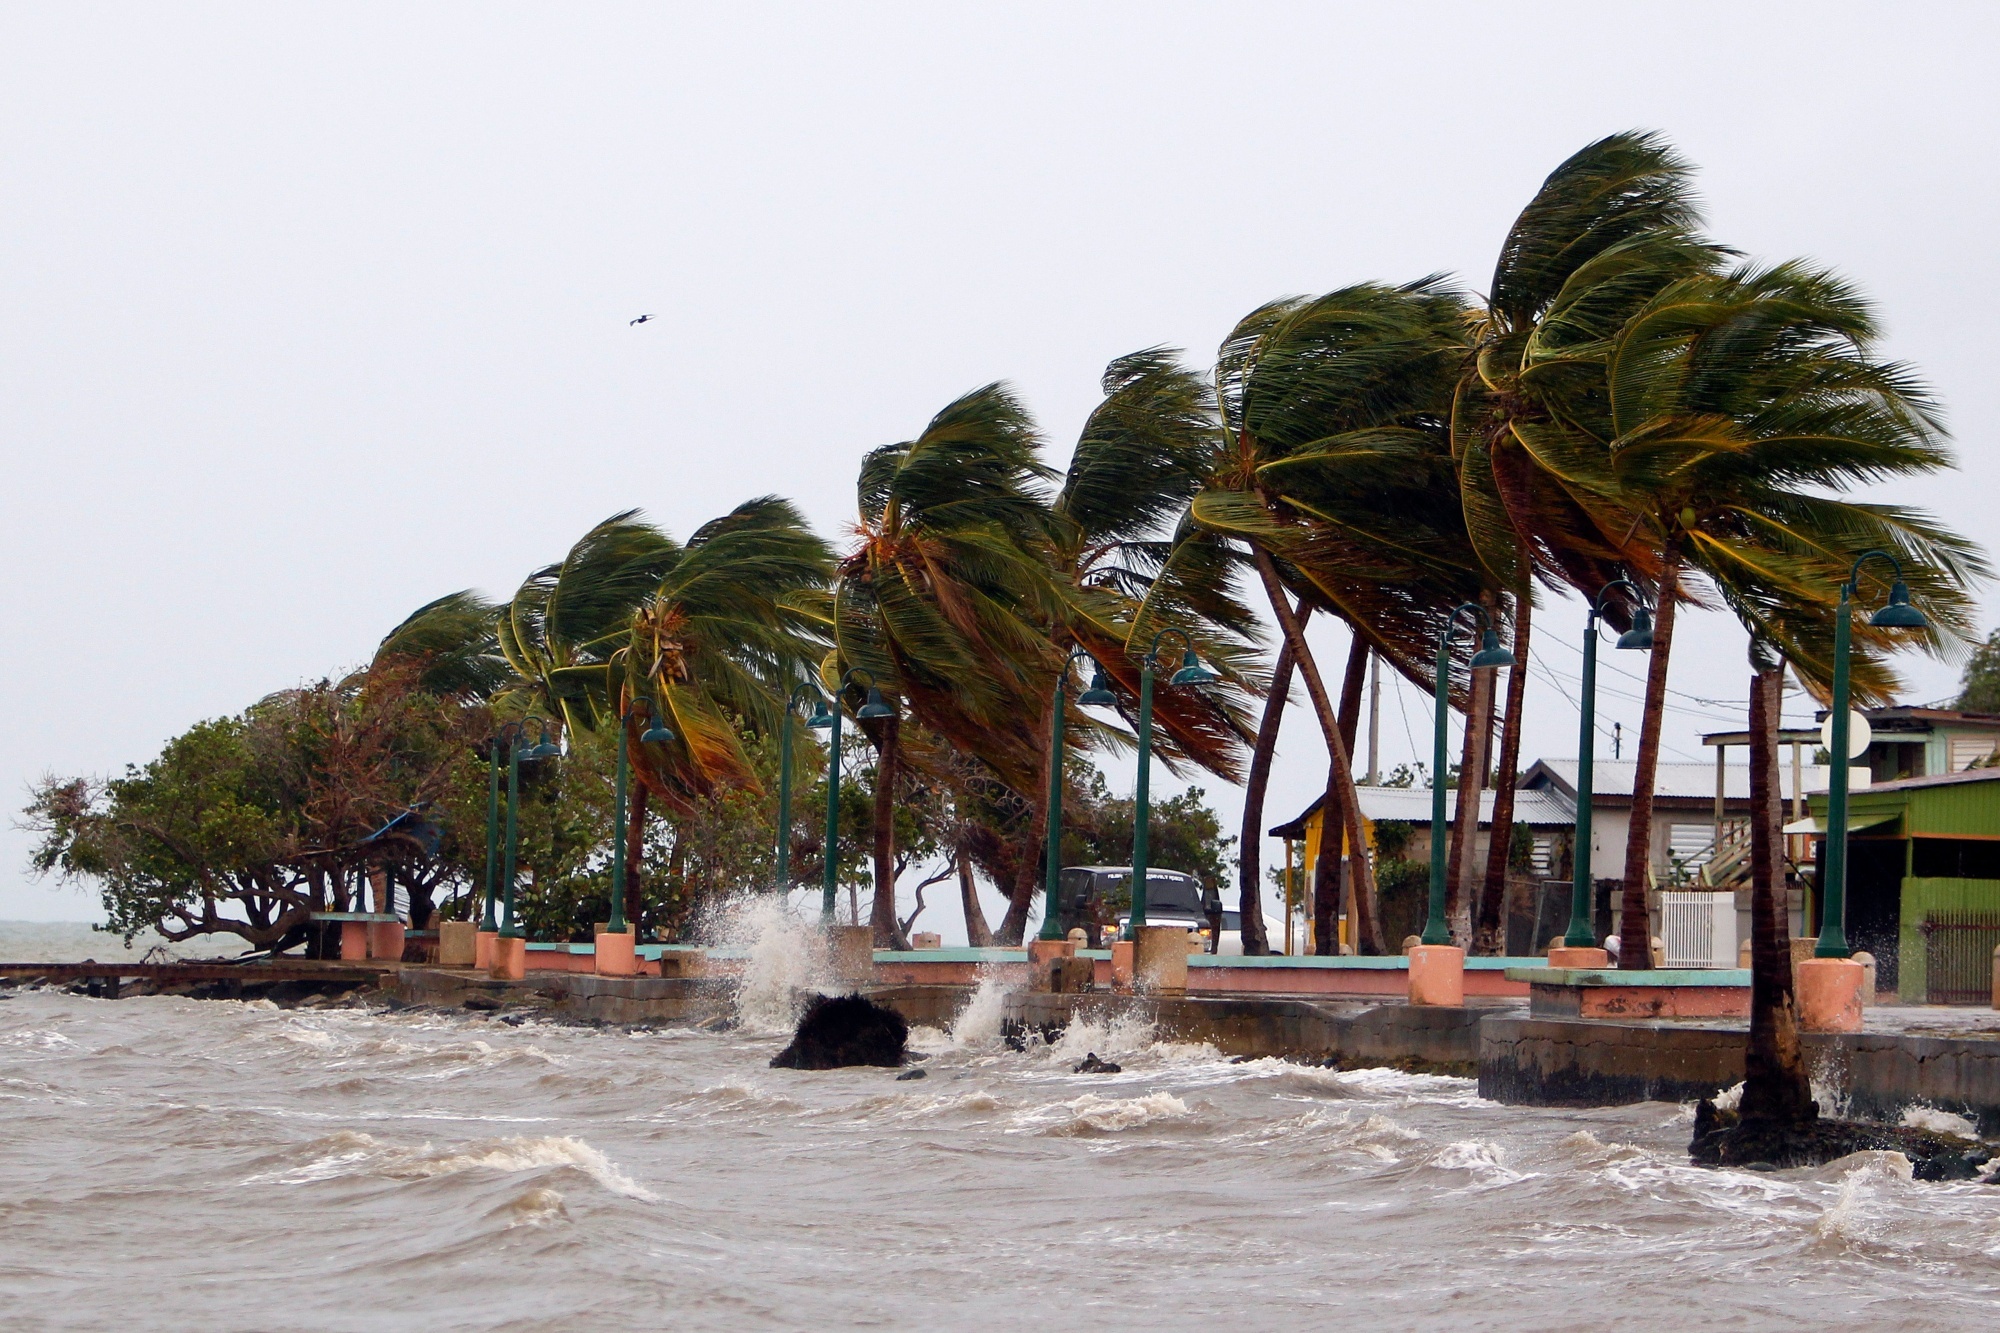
[0,2,2000,933]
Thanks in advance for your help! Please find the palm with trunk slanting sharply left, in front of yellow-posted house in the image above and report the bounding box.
[1188,278,1482,953]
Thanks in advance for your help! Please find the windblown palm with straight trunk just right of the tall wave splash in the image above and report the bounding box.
[822,384,1056,947]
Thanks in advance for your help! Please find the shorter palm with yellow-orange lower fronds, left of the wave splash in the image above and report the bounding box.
[608,496,834,921]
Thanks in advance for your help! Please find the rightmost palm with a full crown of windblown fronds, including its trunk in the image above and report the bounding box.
[1576,264,1986,967]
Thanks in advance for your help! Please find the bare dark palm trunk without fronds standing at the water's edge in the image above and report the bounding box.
[1740,654,1814,1125]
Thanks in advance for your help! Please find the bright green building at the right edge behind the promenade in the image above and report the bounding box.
[1792,769,2000,1005]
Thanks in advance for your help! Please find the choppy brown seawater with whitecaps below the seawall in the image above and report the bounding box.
[0,920,2000,1329]
